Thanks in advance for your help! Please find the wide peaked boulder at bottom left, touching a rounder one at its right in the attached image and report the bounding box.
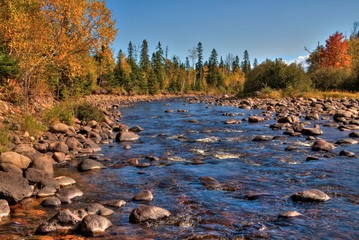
[35,209,82,234]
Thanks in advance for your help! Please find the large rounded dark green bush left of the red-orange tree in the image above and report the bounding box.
[244,59,312,95]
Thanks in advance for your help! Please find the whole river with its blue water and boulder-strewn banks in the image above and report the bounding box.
[0,96,359,239]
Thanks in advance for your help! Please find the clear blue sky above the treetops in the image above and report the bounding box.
[106,0,359,62]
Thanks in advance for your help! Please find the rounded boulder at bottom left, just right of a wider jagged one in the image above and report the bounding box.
[80,215,112,235]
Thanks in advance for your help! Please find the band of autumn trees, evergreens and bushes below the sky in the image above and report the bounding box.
[0,0,359,105]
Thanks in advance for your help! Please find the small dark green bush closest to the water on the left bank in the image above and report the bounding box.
[74,102,105,122]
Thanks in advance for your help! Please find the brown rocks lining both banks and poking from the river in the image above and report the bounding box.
[0,95,359,236]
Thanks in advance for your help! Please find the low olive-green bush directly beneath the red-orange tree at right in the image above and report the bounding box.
[310,67,356,91]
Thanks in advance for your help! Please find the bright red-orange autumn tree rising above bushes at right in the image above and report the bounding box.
[319,32,351,68]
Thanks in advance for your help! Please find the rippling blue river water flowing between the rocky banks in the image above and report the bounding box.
[0,100,359,239]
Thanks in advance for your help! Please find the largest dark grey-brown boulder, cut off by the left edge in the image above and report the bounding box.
[0,172,33,204]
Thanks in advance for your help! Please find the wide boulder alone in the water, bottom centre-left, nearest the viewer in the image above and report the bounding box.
[129,205,171,223]
